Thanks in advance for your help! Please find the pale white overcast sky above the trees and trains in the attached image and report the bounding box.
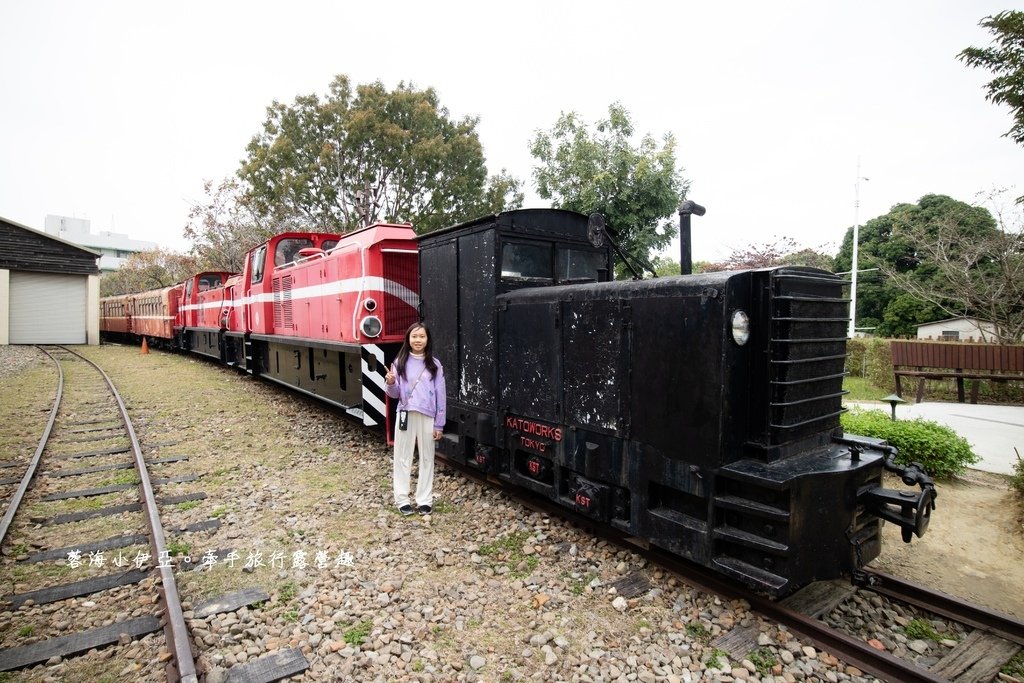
[0,0,1024,260]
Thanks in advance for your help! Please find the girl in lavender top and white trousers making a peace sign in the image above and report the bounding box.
[384,323,445,516]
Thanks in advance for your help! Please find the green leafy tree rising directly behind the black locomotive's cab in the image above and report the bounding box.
[530,102,689,262]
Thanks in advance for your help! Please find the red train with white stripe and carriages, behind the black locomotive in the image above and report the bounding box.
[100,224,420,427]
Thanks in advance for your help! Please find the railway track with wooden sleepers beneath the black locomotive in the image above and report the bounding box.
[458,461,1024,683]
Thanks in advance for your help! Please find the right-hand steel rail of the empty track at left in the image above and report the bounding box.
[66,349,199,683]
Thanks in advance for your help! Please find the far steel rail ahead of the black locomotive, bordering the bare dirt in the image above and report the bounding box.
[854,569,1024,645]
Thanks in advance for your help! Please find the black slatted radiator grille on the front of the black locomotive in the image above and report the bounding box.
[769,268,849,444]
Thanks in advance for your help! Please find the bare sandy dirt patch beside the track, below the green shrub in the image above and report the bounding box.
[872,470,1024,618]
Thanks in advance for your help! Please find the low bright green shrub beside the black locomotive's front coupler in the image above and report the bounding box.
[840,411,981,479]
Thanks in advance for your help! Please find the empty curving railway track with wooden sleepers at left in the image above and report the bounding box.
[0,347,198,683]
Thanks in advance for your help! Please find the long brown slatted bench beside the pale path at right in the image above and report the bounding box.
[891,341,1024,403]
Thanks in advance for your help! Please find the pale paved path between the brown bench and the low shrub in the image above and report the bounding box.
[847,401,1024,474]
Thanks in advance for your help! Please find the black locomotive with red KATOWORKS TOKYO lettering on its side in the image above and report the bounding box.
[419,210,935,595]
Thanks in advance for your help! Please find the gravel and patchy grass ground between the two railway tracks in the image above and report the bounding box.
[0,345,1007,683]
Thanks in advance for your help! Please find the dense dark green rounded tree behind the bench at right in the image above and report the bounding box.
[836,195,996,337]
